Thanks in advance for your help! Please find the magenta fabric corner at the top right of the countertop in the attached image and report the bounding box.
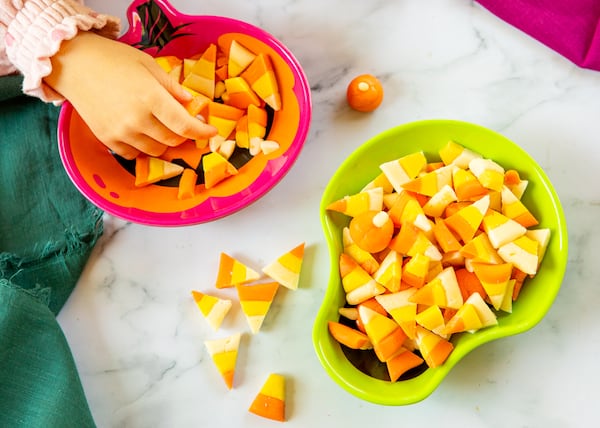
[477,0,600,71]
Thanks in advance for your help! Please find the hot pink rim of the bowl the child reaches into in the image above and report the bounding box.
[57,0,312,226]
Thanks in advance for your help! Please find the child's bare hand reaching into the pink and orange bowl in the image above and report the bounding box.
[44,33,216,159]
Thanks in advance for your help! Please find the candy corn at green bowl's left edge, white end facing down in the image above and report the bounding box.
[340,253,385,305]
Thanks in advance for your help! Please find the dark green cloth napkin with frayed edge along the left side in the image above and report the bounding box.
[0,76,102,428]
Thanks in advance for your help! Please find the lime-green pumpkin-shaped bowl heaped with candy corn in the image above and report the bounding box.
[312,120,568,406]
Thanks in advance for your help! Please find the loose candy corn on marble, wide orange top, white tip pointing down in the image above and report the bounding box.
[235,282,279,334]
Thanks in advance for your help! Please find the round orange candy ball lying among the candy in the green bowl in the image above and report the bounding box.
[348,211,394,253]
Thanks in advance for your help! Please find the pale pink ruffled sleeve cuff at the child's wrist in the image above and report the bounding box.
[0,0,120,103]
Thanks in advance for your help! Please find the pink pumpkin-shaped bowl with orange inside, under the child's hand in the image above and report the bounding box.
[58,0,312,226]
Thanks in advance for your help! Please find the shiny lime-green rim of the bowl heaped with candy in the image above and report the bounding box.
[312,119,568,405]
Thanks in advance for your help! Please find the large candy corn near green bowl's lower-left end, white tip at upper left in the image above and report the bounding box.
[358,305,407,362]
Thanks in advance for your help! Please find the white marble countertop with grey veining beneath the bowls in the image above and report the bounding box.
[59,0,600,428]
